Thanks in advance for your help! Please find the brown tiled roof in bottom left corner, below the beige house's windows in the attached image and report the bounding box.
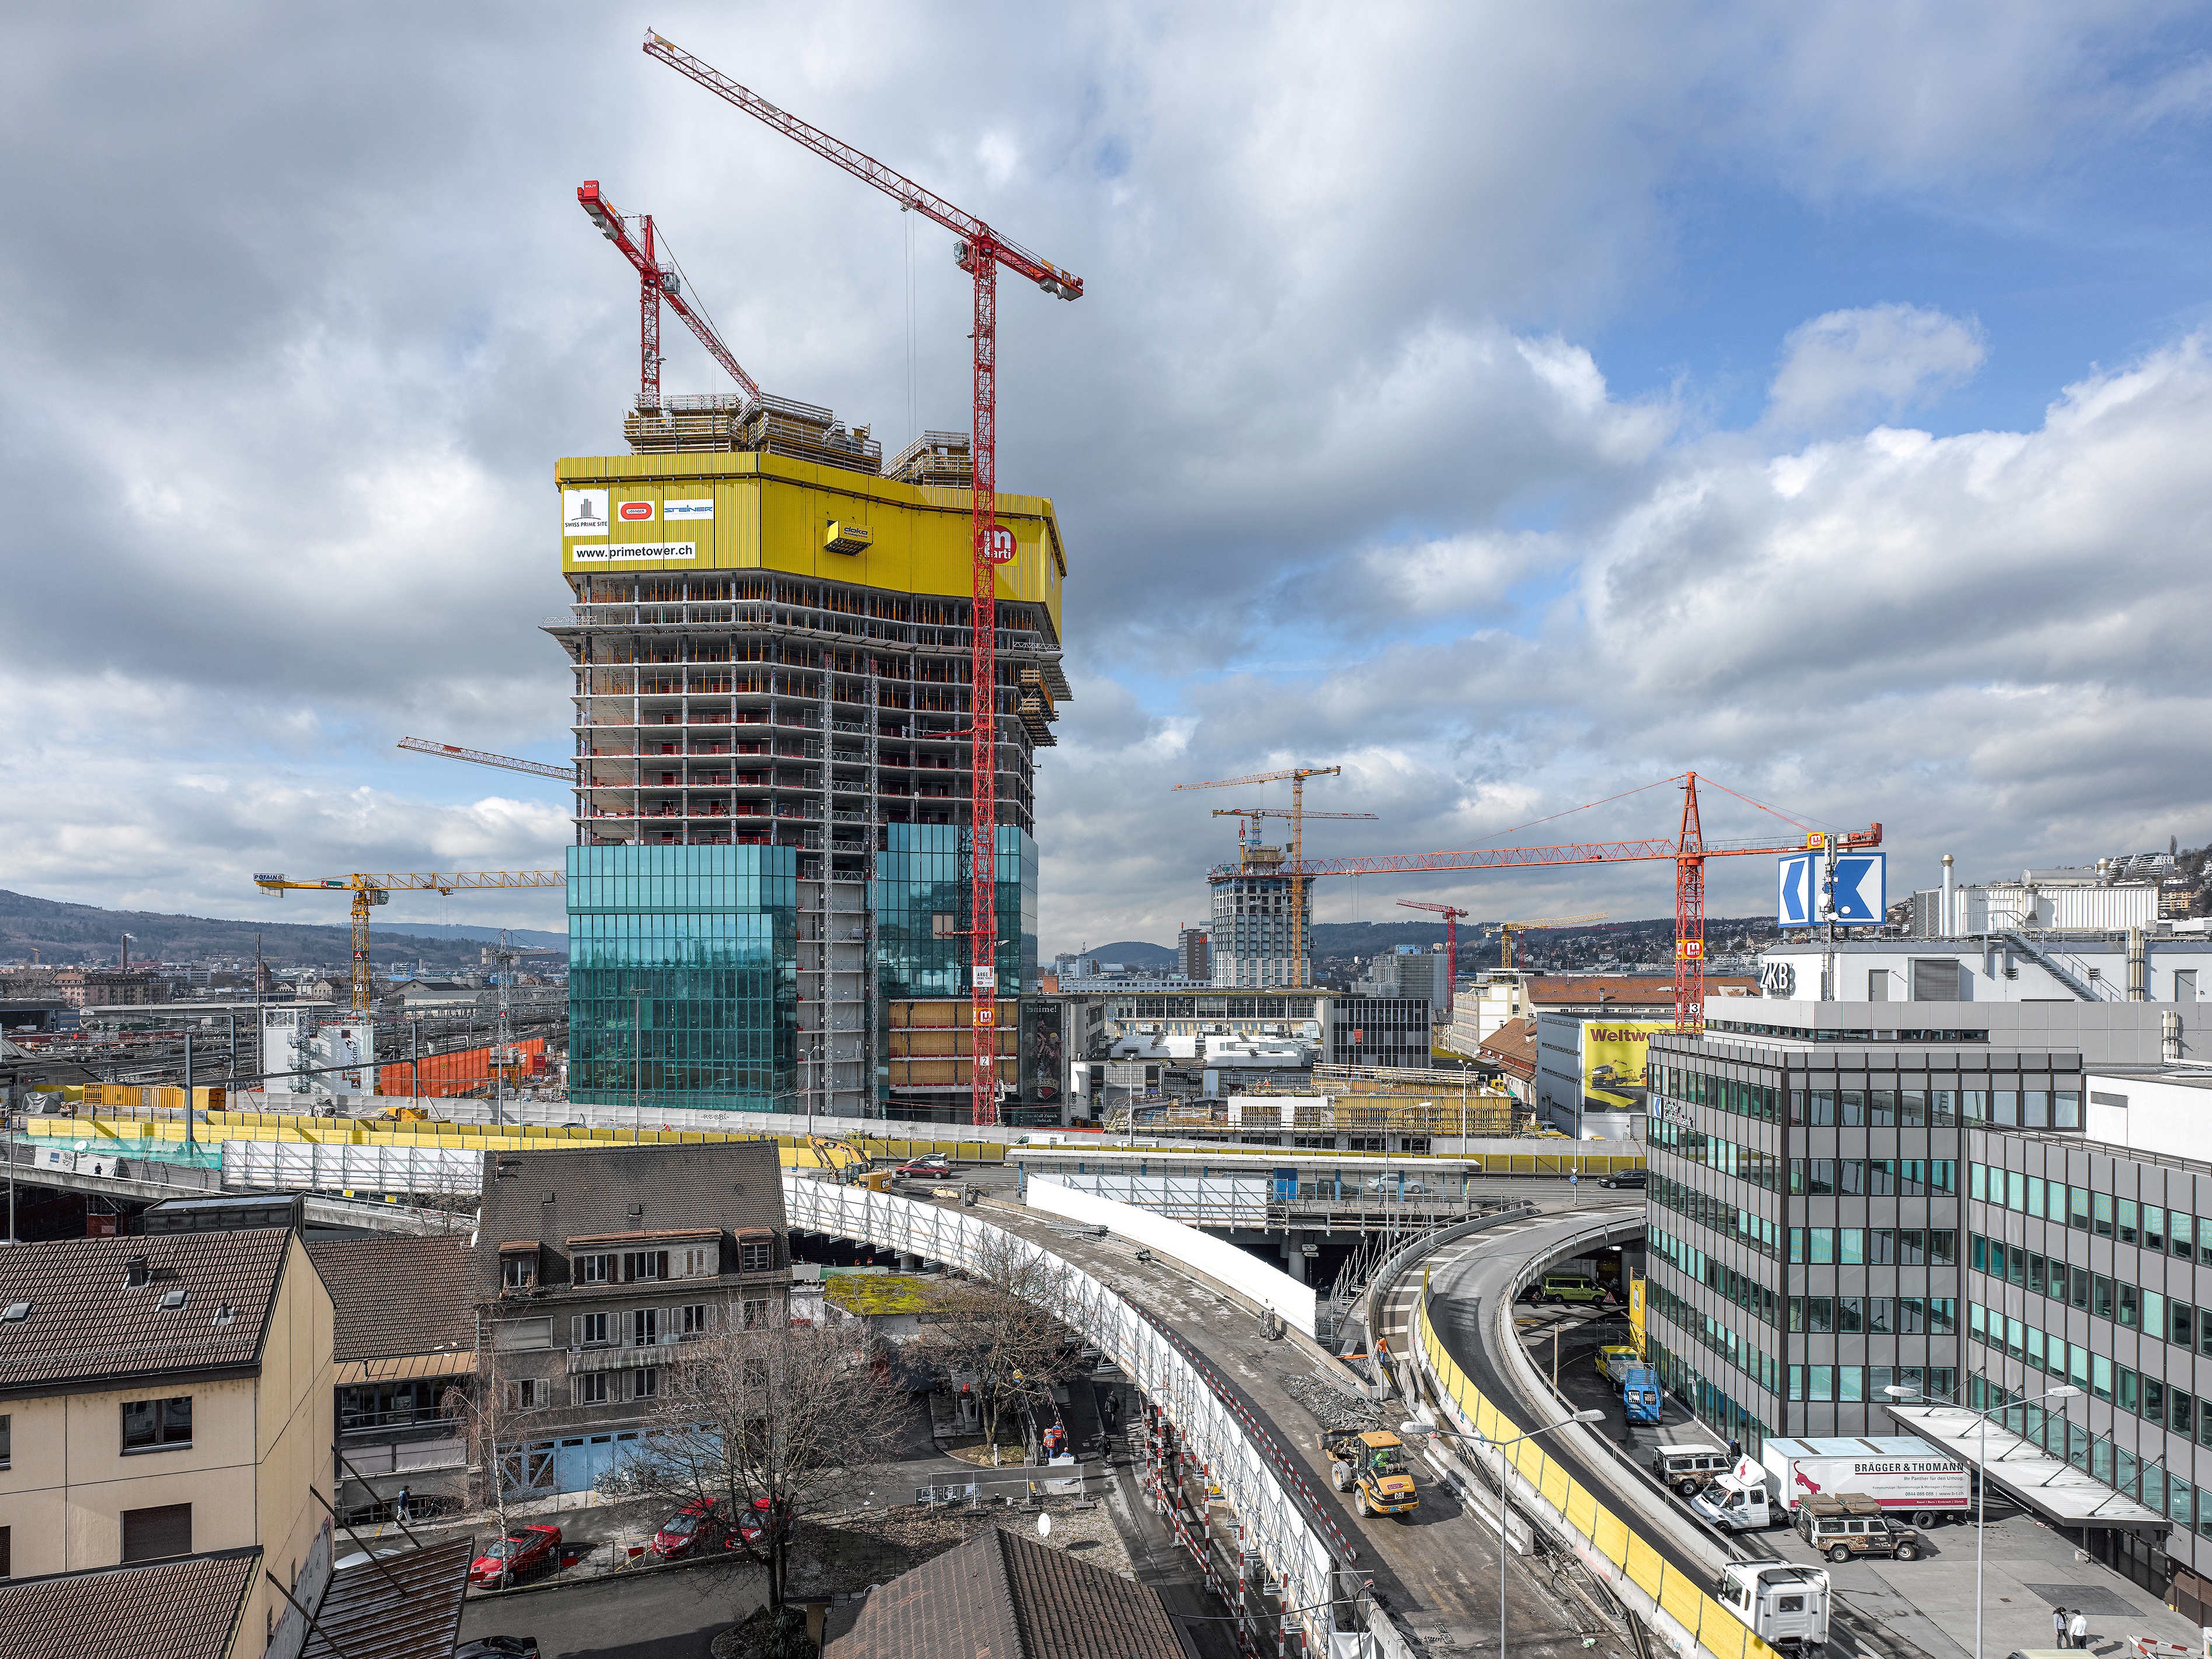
[0,1557,256,1659]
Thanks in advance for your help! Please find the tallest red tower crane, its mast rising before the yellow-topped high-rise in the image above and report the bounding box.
[646,29,1084,1124]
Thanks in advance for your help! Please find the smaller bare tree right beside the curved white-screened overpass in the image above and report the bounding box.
[924,1239,1075,1462]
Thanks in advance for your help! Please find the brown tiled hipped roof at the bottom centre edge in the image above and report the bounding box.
[823,1527,1184,1659]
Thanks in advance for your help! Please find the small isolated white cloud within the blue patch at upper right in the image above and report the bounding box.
[1767,305,1988,431]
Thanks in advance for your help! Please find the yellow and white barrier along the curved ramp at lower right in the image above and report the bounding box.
[1414,1285,1774,1659]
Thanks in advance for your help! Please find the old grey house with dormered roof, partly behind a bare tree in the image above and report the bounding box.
[473,1141,792,1491]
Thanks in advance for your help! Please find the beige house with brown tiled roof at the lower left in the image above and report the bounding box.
[0,1228,334,1641]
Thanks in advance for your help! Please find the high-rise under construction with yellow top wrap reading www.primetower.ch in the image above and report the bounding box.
[546,398,1069,1117]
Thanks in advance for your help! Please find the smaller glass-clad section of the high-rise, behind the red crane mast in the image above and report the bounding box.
[869,823,1038,1000]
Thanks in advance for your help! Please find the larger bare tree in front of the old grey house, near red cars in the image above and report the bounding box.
[626,1323,898,1608]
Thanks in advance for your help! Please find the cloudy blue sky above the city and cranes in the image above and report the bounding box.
[0,0,2212,949]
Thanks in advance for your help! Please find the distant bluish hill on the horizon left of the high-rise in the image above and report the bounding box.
[0,889,568,969]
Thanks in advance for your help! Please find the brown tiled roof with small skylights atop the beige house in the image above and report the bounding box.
[0,1228,292,1393]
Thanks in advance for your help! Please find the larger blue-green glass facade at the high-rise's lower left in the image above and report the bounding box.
[568,847,798,1113]
